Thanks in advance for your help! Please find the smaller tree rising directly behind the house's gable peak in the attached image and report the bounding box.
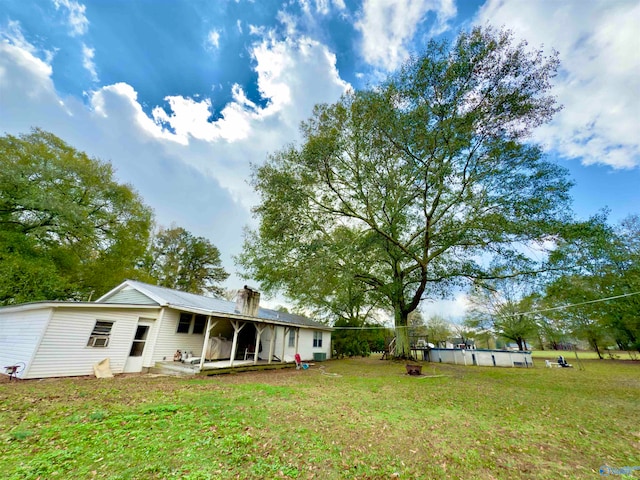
[141,227,229,296]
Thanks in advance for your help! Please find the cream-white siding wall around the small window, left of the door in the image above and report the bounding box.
[28,305,160,378]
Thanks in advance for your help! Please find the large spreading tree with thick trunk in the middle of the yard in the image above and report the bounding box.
[239,28,570,357]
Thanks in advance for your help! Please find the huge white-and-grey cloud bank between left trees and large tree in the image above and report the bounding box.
[0,25,348,288]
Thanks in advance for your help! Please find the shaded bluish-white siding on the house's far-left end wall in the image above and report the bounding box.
[0,307,51,378]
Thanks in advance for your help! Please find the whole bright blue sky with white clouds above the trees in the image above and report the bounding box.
[0,0,640,315]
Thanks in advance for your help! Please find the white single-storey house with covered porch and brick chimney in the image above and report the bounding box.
[0,280,332,379]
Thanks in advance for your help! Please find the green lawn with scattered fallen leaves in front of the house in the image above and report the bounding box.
[0,356,640,480]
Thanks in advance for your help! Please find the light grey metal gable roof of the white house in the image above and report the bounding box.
[96,280,333,330]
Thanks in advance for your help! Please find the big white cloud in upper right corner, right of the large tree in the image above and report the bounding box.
[477,0,640,169]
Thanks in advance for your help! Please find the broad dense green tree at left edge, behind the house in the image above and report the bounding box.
[0,129,152,304]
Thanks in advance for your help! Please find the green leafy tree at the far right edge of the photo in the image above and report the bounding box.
[545,214,640,352]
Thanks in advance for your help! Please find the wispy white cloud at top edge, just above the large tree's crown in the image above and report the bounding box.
[355,0,456,71]
